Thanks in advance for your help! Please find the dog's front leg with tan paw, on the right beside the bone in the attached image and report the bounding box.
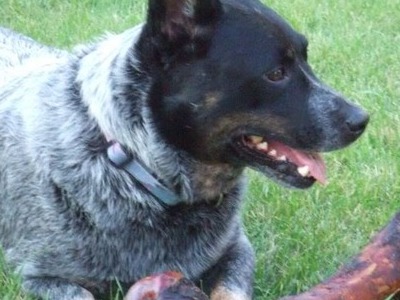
[204,233,254,300]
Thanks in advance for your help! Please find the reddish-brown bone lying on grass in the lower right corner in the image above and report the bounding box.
[281,213,400,300]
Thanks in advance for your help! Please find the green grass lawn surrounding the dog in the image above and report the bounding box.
[0,0,400,300]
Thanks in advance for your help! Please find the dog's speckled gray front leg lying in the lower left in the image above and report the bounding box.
[23,277,95,300]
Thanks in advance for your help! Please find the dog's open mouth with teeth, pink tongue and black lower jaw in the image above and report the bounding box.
[236,135,326,188]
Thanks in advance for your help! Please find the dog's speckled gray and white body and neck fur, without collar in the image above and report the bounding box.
[0,22,254,300]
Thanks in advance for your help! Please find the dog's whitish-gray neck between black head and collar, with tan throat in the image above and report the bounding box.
[75,26,243,203]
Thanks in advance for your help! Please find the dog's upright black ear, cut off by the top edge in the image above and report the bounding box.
[146,0,222,64]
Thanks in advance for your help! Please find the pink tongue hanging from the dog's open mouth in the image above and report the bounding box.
[268,142,326,184]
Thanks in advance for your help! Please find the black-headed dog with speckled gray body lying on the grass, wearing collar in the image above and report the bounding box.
[0,0,369,300]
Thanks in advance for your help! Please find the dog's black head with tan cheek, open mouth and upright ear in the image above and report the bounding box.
[140,0,368,188]
